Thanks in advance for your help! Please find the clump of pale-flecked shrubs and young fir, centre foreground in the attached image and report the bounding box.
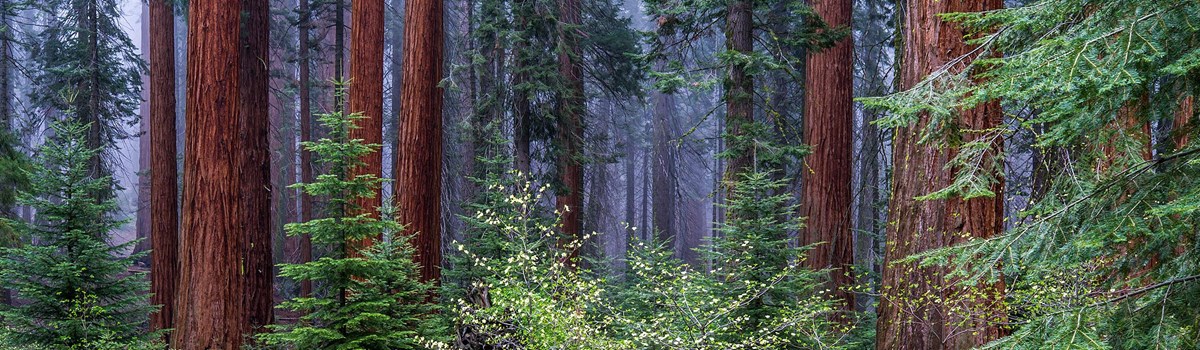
[444,169,847,349]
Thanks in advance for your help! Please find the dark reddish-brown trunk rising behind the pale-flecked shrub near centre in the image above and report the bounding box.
[556,0,587,259]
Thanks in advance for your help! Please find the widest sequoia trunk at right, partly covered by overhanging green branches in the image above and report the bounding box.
[876,0,1004,349]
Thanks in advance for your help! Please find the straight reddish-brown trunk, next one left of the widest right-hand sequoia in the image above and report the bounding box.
[800,0,854,310]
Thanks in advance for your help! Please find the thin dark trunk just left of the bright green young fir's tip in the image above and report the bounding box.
[298,0,317,296]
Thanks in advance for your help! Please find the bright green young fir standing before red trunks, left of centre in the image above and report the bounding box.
[259,111,433,349]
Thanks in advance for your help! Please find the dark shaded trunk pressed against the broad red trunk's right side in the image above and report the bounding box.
[238,0,275,332]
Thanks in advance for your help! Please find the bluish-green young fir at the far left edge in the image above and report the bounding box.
[0,122,157,349]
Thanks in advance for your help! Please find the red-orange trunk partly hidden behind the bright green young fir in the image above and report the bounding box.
[349,0,384,253]
